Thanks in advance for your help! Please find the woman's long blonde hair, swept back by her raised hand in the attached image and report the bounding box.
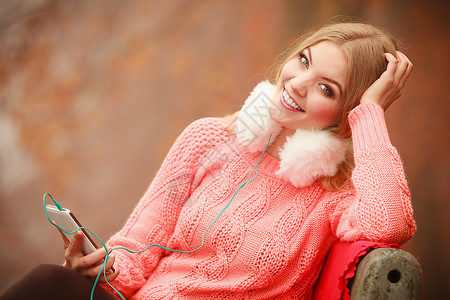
[229,22,398,190]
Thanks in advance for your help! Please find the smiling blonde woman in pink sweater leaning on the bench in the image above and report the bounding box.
[1,23,416,300]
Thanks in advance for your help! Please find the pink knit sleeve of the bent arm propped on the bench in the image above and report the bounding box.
[332,103,416,244]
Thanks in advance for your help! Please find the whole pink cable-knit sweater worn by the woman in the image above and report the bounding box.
[102,104,416,299]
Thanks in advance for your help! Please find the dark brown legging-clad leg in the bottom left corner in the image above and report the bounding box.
[0,265,119,300]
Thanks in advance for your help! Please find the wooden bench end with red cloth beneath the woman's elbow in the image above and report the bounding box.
[313,241,422,300]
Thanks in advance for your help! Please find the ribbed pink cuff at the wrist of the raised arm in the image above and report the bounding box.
[348,103,391,154]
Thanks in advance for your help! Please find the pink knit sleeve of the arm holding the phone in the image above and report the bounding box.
[102,118,223,298]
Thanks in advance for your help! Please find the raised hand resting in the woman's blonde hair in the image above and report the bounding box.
[360,51,413,110]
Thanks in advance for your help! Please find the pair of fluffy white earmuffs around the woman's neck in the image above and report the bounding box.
[236,81,347,187]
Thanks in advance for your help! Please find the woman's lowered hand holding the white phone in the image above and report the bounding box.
[60,230,119,282]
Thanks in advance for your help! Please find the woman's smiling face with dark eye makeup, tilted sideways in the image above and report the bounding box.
[272,41,348,131]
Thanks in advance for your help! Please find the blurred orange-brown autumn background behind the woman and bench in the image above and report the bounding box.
[0,0,450,299]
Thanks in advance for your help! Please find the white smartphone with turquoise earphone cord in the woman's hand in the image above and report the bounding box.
[46,204,97,255]
